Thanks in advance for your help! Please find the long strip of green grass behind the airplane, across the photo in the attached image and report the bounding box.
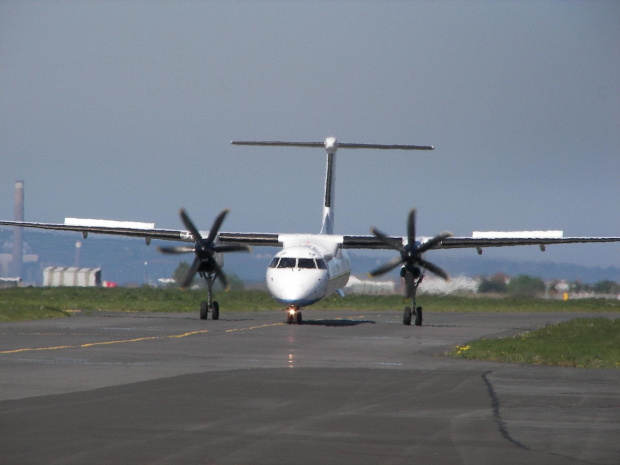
[0,287,620,322]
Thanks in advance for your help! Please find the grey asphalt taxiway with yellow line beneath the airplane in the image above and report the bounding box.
[0,309,620,464]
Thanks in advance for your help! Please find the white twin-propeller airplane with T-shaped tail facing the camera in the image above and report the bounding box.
[0,137,620,326]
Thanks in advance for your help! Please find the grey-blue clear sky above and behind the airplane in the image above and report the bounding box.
[0,0,620,267]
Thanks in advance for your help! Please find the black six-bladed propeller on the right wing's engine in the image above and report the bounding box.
[368,208,452,296]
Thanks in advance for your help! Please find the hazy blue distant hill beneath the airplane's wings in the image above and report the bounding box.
[0,228,620,285]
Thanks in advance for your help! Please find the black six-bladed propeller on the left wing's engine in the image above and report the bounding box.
[157,208,252,289]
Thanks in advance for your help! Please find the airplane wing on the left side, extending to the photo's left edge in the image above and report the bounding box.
[0,219,281,247]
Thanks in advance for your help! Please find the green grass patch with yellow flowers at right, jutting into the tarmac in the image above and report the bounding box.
[450,318,620,369]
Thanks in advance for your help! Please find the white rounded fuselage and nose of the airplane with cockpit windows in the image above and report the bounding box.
[266,234,351,308]
